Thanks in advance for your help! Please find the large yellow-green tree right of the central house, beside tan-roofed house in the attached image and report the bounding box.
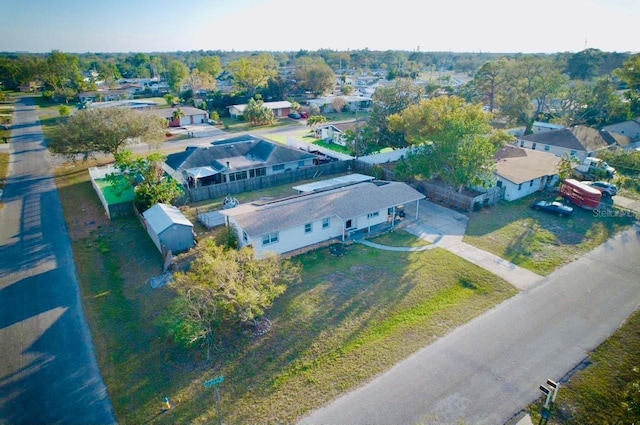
[389,96,510,191]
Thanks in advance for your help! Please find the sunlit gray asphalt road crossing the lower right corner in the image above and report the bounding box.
[300,229,640,425]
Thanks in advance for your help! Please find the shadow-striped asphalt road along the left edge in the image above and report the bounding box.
[0,98,116,425]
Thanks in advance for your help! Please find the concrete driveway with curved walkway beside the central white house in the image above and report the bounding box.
[358,199,543,290]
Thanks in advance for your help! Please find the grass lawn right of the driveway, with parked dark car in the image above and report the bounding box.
[464,194,634,276]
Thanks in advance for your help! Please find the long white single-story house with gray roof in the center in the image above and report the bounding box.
[220,181,425,256]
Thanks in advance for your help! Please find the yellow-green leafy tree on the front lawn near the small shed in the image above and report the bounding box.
[168,239,300,358]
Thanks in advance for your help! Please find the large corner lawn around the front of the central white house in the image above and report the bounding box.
[56,164,516,424]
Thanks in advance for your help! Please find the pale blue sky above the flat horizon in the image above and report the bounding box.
[0,0,640,53]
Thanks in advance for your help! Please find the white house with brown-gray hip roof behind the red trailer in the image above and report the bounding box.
[514,125,631,162]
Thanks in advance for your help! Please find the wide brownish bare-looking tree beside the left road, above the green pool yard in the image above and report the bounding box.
[49,107,167,160]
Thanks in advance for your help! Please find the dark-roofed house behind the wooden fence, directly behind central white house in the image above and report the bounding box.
[165,136,316,187]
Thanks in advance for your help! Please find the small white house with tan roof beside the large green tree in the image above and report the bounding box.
[495,146,562,201]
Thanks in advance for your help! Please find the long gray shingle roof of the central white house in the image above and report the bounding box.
[221,181,424,236]
